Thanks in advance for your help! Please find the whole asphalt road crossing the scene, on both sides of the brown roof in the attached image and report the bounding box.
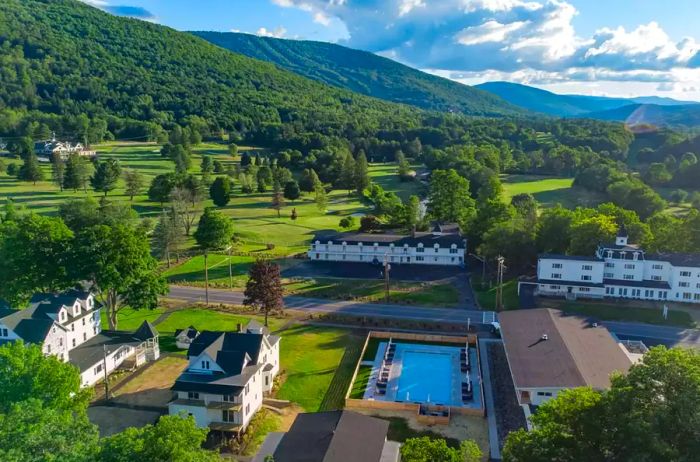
[169,286,700,349]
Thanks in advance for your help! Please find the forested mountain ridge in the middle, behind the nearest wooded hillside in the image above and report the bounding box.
[193,32,523,116]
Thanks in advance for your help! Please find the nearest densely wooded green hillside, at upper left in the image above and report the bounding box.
[0,0,418,141]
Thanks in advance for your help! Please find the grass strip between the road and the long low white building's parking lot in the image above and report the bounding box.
[285,278,459,306]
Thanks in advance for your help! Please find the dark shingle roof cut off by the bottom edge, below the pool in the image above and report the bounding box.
[274,411,389,462]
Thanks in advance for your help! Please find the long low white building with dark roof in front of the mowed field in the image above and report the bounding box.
[308,223,467,266]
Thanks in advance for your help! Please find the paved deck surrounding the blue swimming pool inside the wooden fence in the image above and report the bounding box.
[364,342,483,409]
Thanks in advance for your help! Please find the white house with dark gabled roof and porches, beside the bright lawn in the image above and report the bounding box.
[168,321,280,434]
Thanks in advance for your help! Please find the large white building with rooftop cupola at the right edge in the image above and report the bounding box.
[520,227,700,303]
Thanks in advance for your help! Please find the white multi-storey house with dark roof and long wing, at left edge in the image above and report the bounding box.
[0,290,160,386]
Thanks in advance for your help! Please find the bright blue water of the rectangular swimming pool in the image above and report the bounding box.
[396,351,452,404]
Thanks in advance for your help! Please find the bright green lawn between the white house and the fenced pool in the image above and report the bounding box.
[277,325,362,412]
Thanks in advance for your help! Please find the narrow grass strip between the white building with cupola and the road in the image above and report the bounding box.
[545,300,695,327]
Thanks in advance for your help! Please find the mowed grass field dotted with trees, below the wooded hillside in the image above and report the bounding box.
[0,142,420,255]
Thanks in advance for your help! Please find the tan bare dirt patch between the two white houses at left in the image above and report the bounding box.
[113,356,187,407]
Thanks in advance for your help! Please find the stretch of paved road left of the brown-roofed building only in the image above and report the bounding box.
[168,286,492,324]
